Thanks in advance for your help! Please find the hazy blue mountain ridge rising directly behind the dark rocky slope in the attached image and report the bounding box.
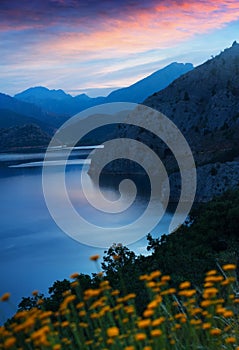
[107,62,193,103]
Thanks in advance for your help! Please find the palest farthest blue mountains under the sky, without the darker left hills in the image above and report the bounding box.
[14,62,193,117]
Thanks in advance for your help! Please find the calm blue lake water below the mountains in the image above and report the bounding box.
[0,149,171,322]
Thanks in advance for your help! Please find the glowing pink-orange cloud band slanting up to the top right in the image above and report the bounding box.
[38,1,239,61]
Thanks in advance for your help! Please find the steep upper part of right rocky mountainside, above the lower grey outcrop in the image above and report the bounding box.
[144,42,239,164]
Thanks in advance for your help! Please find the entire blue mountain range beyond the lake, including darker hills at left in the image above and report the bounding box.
[0,62,193,150]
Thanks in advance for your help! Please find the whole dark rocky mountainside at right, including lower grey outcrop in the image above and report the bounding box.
[90,42,239,201]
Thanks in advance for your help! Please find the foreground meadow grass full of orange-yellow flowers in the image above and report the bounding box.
[0,256,239,350]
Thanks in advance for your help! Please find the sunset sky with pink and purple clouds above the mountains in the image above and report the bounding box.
[0,0,239,96]
